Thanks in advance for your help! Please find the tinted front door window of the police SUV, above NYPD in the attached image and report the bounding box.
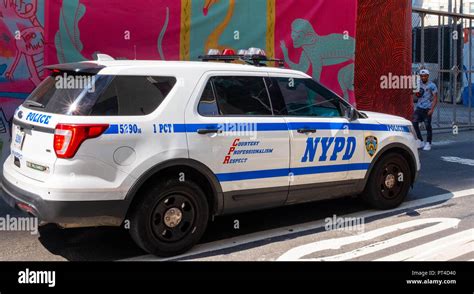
[272,78,342,117]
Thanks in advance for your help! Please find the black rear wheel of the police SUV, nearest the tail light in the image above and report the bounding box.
[129,179,209,257]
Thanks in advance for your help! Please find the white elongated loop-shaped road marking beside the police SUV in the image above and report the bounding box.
[277,218,460,261]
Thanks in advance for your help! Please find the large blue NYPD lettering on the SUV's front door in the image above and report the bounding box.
[301,137,357,162]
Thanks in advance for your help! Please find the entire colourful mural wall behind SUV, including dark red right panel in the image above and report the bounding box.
[0,0,411,162]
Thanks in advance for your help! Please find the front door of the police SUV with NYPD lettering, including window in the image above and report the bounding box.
[270,74,357,203]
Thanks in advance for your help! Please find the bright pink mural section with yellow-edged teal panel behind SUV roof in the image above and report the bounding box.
[46,0,357,102]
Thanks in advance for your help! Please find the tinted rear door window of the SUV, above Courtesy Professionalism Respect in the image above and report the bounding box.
[198,76,272,116]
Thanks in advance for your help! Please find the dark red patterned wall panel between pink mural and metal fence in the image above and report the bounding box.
[354,0,413,120]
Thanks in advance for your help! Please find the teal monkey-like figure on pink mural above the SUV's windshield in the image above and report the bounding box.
[280,18,355,101]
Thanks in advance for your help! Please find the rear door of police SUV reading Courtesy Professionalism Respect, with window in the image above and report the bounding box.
[186,72,290,212]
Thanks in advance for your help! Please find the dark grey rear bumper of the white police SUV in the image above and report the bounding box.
[0,174,129,227]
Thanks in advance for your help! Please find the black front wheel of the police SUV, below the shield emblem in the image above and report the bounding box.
[362,153,412,209]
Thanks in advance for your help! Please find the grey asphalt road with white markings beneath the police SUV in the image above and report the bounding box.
[0,132,474,261]
